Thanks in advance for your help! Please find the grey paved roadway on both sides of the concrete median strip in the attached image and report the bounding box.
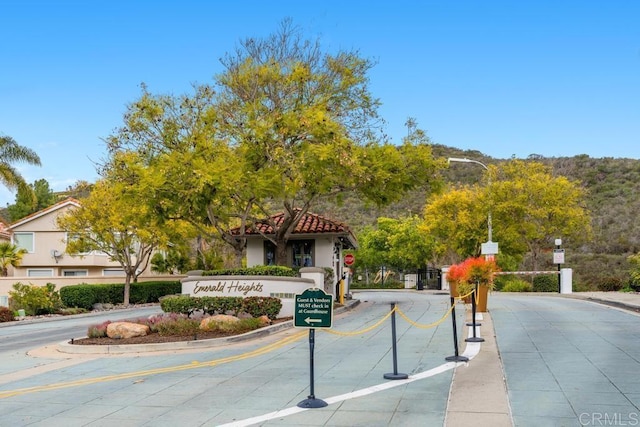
[0,291,640,427]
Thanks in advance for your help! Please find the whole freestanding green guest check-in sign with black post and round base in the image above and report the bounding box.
[293,288,333,408]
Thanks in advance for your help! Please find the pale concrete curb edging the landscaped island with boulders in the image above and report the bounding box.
[57,300,360,354]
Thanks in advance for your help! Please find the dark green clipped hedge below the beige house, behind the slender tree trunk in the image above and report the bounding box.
[60,281,182,310]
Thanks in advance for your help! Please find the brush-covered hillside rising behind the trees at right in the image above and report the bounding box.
[316,145,640,290]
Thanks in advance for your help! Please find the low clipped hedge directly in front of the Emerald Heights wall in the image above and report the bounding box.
[160,295,282,319]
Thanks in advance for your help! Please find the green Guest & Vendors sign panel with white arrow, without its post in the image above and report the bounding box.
[293,288,333,328]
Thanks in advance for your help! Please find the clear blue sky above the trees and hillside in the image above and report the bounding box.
[0,0,640,206]
